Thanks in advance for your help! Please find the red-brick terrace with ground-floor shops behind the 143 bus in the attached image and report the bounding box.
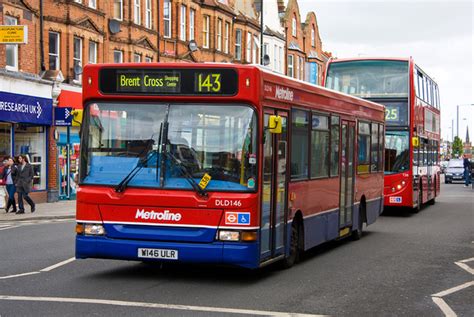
[0,0,327,201]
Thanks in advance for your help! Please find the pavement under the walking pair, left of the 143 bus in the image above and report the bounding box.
[0,200,76,223]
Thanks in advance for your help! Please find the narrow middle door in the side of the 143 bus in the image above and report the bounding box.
[339,120,355,230]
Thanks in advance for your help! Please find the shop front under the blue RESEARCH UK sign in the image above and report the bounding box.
[0,77,53,202]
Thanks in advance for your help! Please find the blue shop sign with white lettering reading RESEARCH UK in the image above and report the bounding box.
[0,91,53,125]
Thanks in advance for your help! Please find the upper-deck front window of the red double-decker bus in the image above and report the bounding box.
[326,60,409,98]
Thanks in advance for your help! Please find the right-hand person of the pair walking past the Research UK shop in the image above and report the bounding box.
[15,154,35,214]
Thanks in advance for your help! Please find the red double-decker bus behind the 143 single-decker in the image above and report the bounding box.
[325,58,440,212]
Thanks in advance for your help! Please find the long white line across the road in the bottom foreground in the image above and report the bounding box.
[0,295,326,317]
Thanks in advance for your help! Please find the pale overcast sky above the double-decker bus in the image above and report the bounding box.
[298,0,474,142]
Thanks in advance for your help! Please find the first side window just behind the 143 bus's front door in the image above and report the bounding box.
[291,109,309,179]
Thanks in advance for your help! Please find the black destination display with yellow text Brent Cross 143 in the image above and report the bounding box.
[99,68,238,96]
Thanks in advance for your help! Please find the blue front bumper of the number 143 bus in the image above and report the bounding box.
[76,235,260,269]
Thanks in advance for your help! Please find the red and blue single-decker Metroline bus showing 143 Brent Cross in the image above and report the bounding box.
[76,63,384,269]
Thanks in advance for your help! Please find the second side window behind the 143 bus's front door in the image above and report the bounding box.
[311,113,329,178]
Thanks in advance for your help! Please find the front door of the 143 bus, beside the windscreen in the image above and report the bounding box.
[260,109,288,261]
